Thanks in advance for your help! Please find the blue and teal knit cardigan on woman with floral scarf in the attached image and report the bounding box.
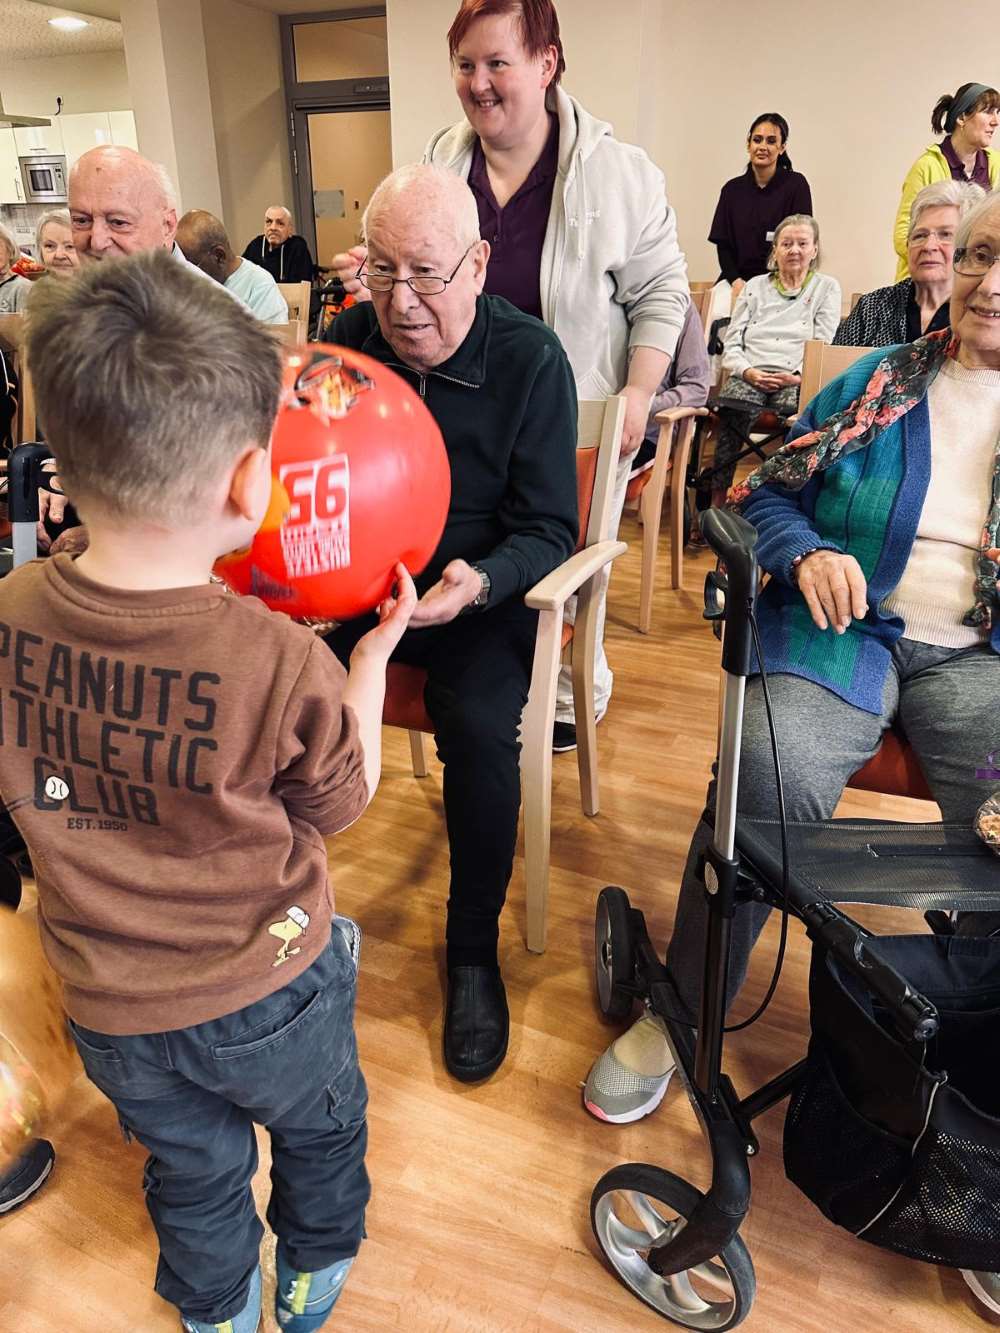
[743,348,1000,713]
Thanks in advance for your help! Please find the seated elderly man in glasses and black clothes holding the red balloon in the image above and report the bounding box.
[327,167,577,1082]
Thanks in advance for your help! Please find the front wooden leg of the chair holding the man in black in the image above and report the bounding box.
[521,608,563,953]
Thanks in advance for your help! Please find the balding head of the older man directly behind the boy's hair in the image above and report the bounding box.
[69,144,177,260]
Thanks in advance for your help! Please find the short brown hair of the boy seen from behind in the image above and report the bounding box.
[27,251,281,525]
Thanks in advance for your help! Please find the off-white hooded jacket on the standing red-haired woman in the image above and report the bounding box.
[424,87,689,399]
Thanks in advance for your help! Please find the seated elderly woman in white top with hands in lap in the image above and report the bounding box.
[712,213,840,504]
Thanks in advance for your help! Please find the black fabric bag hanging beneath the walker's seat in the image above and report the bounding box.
[784,934,1000,1272]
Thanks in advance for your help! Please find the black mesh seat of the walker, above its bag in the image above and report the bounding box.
[736,818,1000,912]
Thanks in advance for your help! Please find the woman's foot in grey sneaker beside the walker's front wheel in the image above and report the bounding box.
[584,1010,673,1125]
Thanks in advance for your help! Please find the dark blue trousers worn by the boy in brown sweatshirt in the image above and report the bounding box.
[71,930,371,1324]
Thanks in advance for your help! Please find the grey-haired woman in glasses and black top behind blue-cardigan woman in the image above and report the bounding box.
[833,180,985,347]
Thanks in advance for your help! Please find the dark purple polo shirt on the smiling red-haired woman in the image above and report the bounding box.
[469,115,559,320]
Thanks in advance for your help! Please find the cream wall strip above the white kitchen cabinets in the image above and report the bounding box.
[0,49,132,116]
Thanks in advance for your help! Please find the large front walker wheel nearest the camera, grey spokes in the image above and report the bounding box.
[591,1162,757,1333]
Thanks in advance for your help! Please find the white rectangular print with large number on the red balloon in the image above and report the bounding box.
[279,453,351,579]
